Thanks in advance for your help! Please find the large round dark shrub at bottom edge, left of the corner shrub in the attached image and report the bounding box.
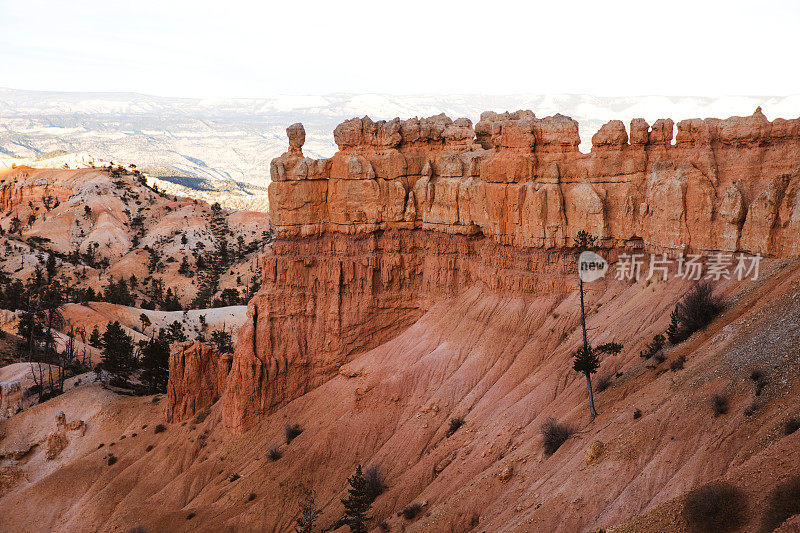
[683,483,747,533]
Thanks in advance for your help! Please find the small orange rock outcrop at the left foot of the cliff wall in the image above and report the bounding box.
[167,342,231,422]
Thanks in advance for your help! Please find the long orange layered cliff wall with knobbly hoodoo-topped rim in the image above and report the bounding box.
[183,109,800,431]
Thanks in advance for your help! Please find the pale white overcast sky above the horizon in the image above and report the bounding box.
[0,0,800,98]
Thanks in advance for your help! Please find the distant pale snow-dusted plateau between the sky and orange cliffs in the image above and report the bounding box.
[0,88,800,208]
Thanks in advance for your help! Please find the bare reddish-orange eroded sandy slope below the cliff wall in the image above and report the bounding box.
[0,261,800,531]
